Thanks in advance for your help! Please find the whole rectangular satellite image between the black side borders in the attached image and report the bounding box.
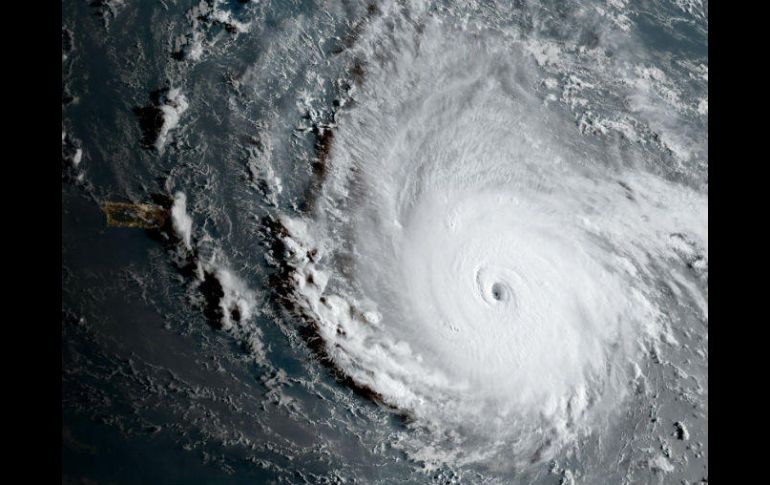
[61,0,708,485]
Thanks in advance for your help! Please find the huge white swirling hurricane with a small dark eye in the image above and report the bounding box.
[282,6,707,463]
